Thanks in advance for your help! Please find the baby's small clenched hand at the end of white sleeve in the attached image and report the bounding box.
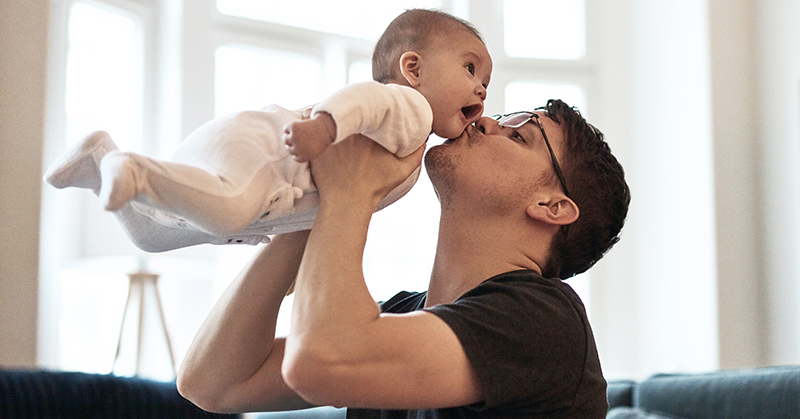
[283,112,336,163]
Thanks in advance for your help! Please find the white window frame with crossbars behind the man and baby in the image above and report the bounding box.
[39,0,600,376]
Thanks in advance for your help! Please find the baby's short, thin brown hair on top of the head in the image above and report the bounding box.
[372,9,485,84]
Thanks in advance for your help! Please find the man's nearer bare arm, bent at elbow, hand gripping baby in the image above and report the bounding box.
[283,136,483,409]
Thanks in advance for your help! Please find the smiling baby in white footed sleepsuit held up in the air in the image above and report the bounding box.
[45,9,492,252]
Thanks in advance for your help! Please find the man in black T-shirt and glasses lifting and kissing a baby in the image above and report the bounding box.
[179,101,629,418]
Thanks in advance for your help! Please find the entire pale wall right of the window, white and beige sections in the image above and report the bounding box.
[592,0,800,378]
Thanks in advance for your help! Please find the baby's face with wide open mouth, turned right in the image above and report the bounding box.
[417,30,492,138]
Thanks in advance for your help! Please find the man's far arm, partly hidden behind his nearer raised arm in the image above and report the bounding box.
[178,231,309,412]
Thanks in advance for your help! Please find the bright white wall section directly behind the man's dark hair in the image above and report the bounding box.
[591,0,718,378]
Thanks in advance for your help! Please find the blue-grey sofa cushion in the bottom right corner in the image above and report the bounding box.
[633,366,800,419]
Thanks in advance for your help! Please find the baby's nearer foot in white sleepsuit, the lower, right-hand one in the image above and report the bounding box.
[98,151,137,211]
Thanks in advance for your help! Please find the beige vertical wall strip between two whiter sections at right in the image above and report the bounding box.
[709,0,766,368]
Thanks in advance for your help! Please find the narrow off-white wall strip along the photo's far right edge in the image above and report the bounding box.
[756,0,800,364]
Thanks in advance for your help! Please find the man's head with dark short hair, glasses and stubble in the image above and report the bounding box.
[425,100,630,279]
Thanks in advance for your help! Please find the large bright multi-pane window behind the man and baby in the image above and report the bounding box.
[42,0,594,378]
